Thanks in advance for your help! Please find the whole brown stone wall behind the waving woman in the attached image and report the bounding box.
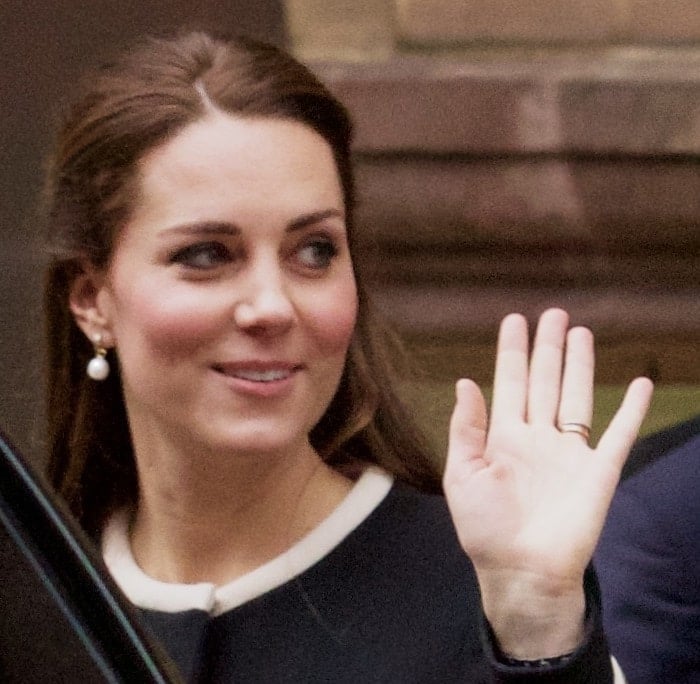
[286,0,700,383]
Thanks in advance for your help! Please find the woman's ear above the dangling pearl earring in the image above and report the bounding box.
[68,263,114,348]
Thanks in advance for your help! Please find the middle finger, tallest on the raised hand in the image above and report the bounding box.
[527,309,569,425]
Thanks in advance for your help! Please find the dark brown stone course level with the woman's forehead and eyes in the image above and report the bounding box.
[357,154,700,248]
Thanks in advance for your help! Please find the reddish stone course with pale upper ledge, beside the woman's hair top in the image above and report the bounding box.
[312,53,700,156]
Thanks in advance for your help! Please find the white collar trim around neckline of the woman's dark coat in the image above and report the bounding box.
[102,466,393,616]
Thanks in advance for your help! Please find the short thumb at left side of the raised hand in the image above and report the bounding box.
[445,379,487,479]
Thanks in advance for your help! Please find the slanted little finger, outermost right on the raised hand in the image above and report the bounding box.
[596,378,654,470]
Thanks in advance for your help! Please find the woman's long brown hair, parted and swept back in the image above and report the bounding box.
[45,33,440,536]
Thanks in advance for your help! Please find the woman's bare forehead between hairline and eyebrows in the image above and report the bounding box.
[131,112,343,226]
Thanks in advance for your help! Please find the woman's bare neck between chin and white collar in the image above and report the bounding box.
[131,436,351,584]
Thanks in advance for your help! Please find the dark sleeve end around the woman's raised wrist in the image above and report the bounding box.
[482,567,613,684]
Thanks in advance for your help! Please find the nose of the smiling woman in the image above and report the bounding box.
[234,263,295,334]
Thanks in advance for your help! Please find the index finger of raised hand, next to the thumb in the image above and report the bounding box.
[491,314,528,423]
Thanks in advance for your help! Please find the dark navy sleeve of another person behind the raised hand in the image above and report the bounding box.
[595,437,700,684]
